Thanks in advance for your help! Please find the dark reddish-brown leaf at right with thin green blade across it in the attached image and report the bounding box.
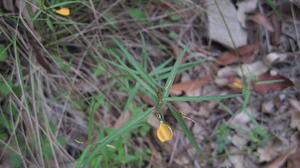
[254,73,293,94]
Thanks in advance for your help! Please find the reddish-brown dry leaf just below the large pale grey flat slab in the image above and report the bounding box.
[217,44,259,65]
